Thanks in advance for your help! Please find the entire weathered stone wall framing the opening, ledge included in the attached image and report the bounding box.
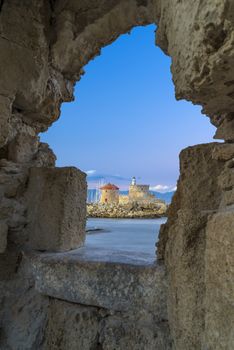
[0,0,234,350]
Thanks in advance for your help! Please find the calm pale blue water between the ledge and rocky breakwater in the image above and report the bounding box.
[85,218,166,254]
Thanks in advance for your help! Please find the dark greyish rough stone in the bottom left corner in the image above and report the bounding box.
[0,254,49,350]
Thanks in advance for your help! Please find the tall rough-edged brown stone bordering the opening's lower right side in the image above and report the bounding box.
[158,144,228,349]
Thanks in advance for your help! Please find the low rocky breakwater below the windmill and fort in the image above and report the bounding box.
[87,202,167,218]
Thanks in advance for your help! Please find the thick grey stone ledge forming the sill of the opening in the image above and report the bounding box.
[30,247,167,319]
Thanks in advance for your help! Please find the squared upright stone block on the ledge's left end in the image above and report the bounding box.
[26,168,87,251]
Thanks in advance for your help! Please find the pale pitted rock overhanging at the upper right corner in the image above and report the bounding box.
[157,0,234,133]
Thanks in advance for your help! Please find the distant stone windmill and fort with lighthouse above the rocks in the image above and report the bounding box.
[100,177,165,205]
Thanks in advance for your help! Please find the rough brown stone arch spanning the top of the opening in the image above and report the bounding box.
[0,0,234,137]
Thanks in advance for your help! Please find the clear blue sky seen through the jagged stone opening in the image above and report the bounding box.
[41,25,215,191]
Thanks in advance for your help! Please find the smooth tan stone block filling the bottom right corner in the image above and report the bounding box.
[204,211,234,350]
